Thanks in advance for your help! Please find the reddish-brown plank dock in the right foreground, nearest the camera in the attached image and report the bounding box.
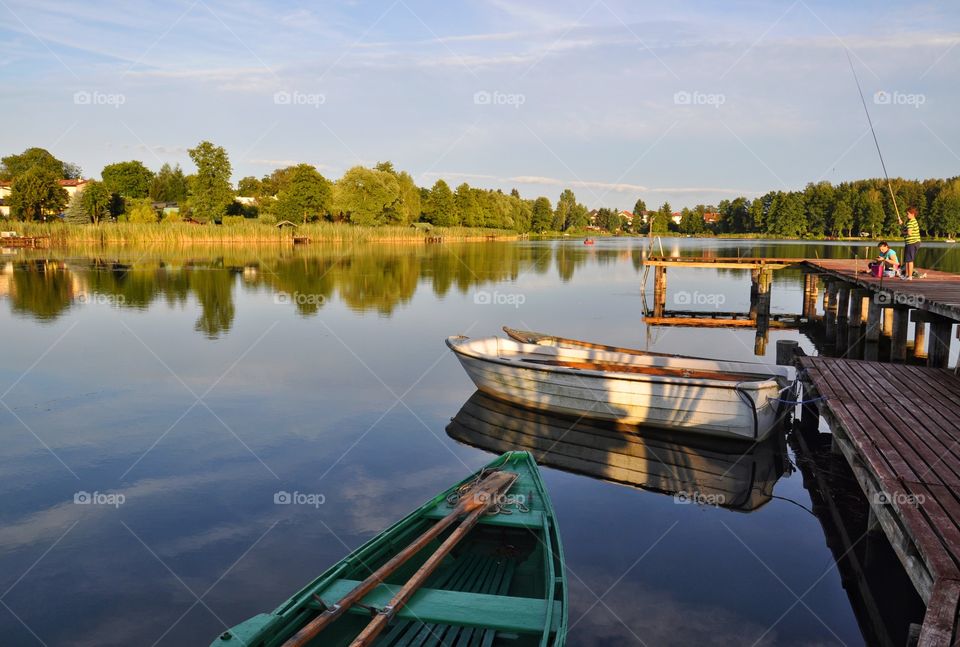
[799,357,960,647]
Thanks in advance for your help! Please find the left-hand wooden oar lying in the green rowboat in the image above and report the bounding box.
[283,471,517,647]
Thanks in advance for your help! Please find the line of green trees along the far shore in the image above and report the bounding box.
[0,141,960,238]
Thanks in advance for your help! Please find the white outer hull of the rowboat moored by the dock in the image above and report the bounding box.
[448,338,781,440]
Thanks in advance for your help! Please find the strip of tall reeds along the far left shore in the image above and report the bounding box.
[9,222,517,245]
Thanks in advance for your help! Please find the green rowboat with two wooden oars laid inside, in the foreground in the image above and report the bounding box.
[211,451,567,647]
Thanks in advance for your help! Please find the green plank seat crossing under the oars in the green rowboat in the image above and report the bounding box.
[318,579,563,634]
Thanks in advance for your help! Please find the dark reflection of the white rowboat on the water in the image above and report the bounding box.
[447,391,787,512]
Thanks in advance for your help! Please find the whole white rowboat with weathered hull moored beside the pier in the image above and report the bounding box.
[447,336,791,440]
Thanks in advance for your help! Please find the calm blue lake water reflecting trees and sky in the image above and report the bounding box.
[0,239,960,645]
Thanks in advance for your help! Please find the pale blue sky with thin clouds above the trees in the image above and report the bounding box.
[0,0,960,209]
